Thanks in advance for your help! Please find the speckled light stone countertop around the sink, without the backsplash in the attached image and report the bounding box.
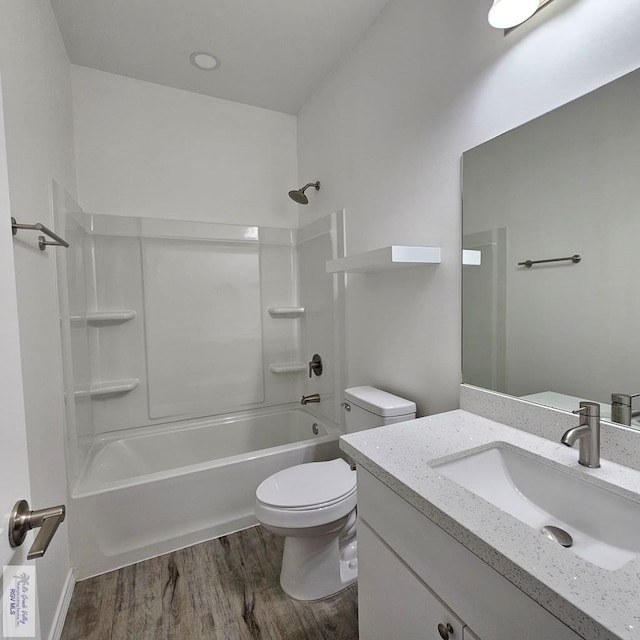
[340,410,640,640]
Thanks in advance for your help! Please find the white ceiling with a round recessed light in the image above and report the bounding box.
[51,0,388,114]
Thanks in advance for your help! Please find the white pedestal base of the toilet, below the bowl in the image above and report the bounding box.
[280,511,358,601]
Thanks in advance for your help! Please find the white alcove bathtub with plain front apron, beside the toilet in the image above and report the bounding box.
[69,405,340,579]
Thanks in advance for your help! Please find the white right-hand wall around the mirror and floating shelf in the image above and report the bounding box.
[298,0,640,414]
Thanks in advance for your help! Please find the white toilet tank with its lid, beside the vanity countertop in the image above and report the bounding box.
[344,387,416,433]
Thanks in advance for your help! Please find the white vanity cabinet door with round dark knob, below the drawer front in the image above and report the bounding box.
[358,521,463,640]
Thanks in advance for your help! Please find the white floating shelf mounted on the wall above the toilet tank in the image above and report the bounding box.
[327,245,440,273]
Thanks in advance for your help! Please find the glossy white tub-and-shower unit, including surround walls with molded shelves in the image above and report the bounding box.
[53,198,345,579]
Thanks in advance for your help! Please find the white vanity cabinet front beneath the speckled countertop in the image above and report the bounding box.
[358,466,581,640]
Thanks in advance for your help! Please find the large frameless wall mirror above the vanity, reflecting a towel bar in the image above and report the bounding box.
[462,69,640,428]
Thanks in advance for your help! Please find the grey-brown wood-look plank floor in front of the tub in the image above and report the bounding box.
[62,527,358,640]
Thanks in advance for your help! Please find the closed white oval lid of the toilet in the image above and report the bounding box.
[256,458,356,509]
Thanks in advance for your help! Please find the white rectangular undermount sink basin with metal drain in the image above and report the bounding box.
[432,443,640,571]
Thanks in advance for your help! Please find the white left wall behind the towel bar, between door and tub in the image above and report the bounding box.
[0,0,75,637]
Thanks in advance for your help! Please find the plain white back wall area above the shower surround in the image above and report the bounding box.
[72,65,298,227]
